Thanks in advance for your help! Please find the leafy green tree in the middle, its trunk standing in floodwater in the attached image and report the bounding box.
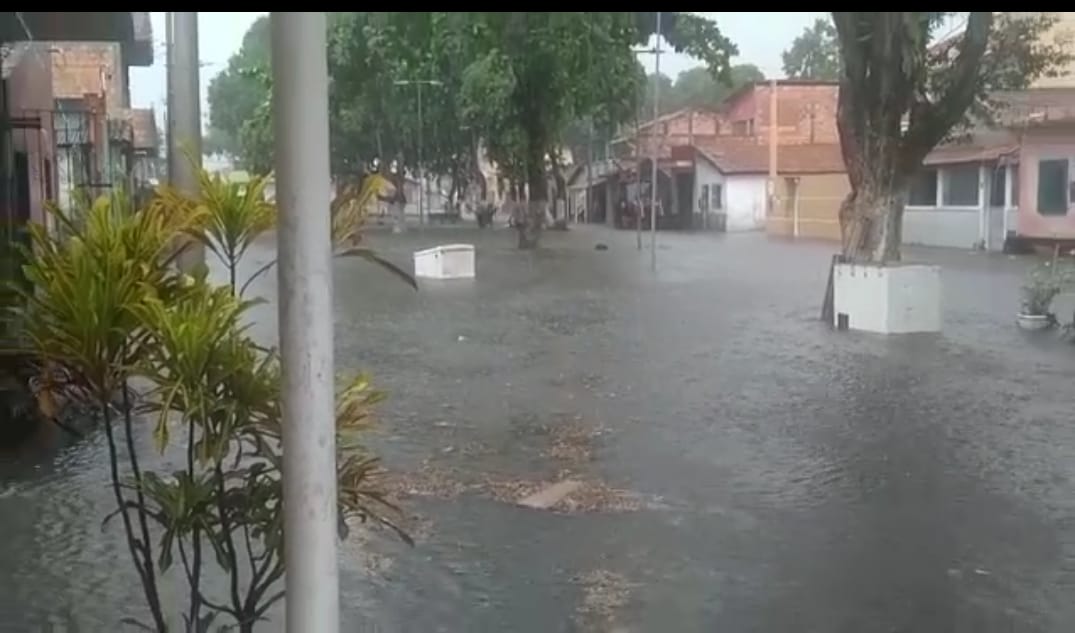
[438,12,735,248]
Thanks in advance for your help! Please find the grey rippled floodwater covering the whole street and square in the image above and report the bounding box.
[0,228,1075,633]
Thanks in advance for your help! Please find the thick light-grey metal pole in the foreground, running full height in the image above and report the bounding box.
[270,12,340,633]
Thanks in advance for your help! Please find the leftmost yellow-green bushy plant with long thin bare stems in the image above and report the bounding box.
[13,190,198,631]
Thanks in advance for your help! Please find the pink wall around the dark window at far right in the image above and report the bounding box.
[1016,130,1075,240]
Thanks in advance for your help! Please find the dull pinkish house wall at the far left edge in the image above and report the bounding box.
[8,45,56,222]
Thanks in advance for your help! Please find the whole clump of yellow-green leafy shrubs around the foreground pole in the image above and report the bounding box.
[14,179,406,632]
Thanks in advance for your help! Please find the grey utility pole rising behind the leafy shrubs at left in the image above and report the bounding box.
[168,11,205,271]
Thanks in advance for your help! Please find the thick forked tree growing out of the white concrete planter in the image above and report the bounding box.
[833,12,1071,262]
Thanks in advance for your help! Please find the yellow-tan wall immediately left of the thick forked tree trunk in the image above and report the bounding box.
[765,173,850,241]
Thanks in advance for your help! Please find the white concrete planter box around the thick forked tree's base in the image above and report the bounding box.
[832,263,941,334]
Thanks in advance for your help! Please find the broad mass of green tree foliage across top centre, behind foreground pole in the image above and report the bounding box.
[210,12,736,243]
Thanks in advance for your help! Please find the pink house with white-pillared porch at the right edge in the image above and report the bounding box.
[903,88,1075,250]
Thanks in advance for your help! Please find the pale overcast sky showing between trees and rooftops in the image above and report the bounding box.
[130,12,825,120]
